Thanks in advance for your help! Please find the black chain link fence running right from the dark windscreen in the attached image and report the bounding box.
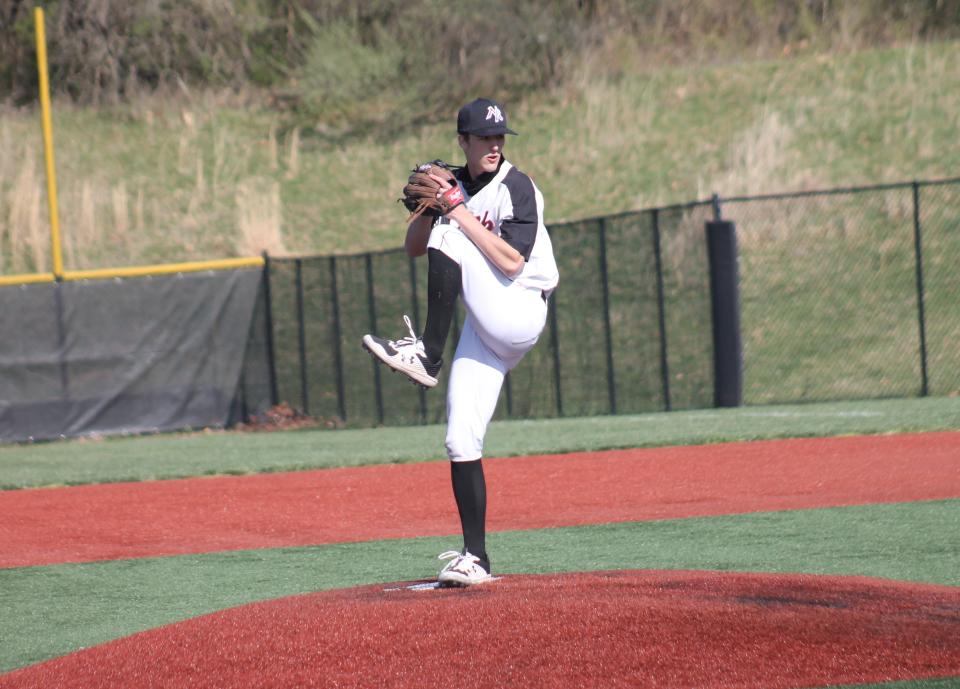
[240,179,960,426]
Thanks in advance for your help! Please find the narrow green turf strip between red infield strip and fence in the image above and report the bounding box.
[0,397,960,489]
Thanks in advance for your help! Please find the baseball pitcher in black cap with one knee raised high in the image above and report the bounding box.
[363,98,559,586]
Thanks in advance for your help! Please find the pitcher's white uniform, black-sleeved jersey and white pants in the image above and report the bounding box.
[427,160,559,461]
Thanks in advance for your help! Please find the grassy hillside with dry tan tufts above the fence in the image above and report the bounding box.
[0,42,960,273]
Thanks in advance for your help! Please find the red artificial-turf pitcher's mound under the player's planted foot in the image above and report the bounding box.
[0,571,960,689]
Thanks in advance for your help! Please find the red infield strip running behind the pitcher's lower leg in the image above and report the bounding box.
[0,432,960,568]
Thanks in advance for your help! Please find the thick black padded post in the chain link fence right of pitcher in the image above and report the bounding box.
[707,221,743,407]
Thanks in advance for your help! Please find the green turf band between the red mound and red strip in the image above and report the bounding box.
[0,500,960,671]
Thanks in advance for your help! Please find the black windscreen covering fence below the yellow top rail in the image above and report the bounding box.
[0,268,264,442]
